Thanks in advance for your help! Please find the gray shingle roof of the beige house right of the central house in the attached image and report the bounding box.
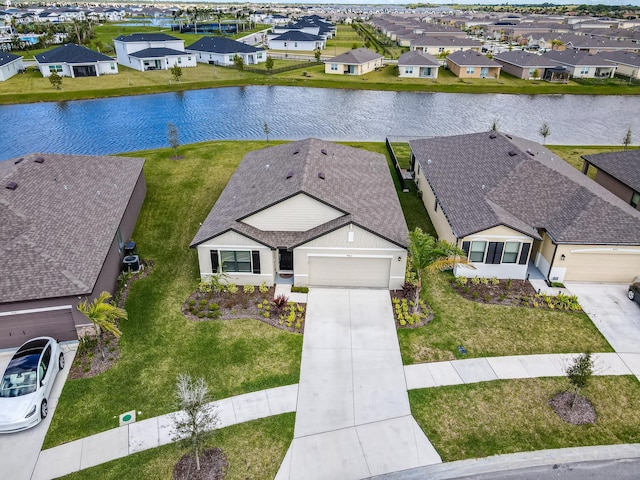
[409,132,640,245]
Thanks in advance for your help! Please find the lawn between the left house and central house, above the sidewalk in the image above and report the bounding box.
[45,142,302,448]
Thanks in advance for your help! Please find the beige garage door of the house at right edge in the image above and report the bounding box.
[559,253,640,283]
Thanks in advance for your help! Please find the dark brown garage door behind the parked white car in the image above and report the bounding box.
[0,310,78,348]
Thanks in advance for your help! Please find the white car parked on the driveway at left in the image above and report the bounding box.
[0,337,64,433]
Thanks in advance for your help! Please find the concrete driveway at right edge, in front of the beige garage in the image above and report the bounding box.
[565,283,640,353]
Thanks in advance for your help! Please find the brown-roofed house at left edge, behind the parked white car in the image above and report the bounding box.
[0,154,146,348]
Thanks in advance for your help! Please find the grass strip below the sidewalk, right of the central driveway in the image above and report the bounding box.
[409,376,640,462]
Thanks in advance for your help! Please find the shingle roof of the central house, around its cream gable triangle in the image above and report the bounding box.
[191,138,408,248]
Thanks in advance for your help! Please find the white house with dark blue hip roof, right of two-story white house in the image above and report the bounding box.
[185,37,267,65]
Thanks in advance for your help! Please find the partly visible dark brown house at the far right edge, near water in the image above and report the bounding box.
[582,150,640,210]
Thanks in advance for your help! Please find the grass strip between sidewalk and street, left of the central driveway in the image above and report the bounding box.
[61,413,295,480]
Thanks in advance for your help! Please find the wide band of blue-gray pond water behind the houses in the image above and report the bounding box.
[0,86,640,160]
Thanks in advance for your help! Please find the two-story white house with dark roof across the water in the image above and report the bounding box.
[113,33,196,72]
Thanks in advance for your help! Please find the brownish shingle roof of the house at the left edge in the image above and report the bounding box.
[0,154,144,303]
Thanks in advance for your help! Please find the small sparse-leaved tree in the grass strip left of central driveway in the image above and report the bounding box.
[173,373,220,470]
